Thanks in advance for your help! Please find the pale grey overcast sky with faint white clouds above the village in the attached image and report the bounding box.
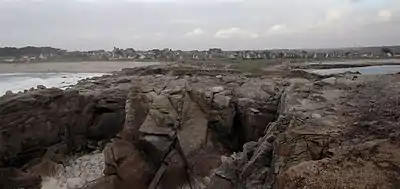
[0,0,400,50]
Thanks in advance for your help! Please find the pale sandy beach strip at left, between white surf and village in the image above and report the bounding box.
[0,61,159,73]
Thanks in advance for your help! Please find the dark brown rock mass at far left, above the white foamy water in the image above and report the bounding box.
[0,85,126,166]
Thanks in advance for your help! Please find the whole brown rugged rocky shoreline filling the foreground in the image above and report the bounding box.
[0,65,400,189]
